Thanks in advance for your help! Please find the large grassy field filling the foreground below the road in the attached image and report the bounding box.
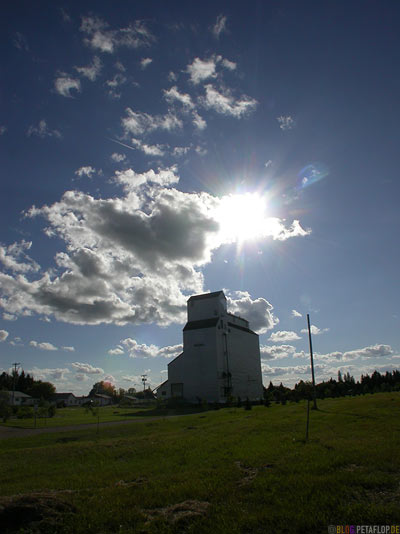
[0,393,400,534]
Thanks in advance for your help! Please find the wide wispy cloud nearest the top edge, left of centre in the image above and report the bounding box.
[80,16,154,53]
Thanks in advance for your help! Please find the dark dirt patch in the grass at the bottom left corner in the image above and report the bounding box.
[0,493,76,534]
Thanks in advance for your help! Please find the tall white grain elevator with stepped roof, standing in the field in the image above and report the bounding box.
[157,291,263,403]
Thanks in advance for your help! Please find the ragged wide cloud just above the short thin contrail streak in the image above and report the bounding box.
[121,108,183,135]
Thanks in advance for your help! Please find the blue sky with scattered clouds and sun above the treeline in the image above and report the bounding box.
[0,1,400,394]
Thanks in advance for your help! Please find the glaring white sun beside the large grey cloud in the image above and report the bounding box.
[216,193,266,242]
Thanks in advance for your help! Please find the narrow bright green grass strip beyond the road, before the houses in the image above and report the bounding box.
[0,406,155,428]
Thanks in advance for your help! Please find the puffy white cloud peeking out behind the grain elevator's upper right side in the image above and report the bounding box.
[227,291,279,334]
